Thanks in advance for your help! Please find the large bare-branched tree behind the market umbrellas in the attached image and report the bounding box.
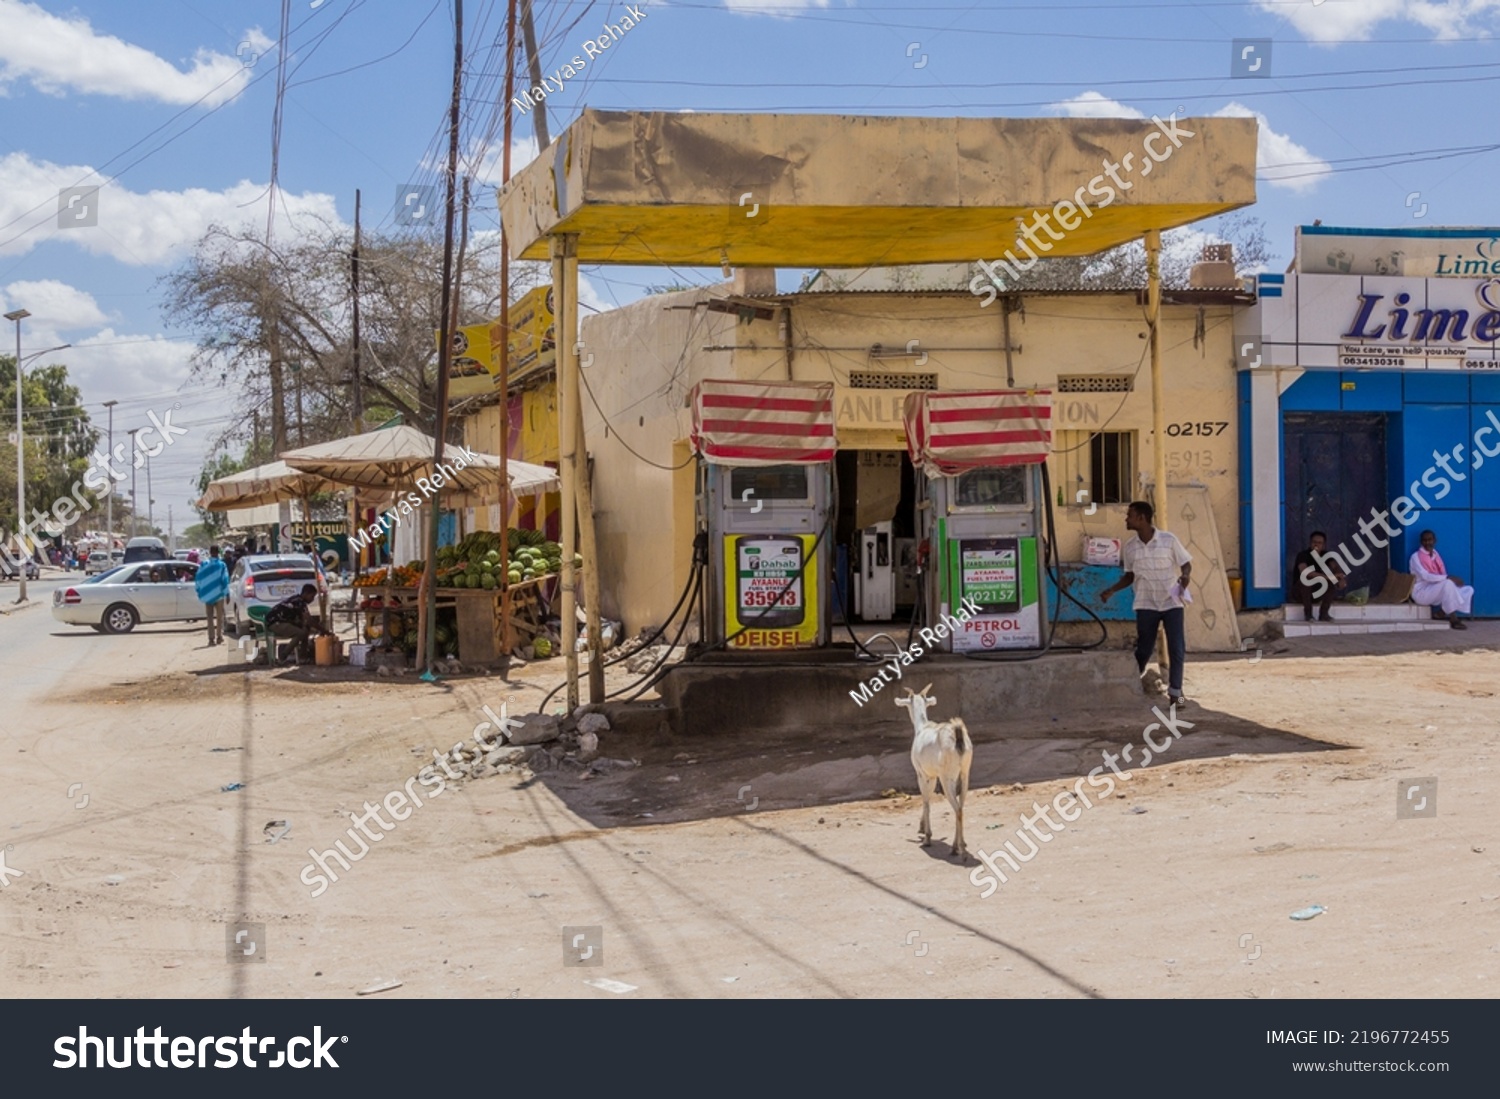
[164,218,545,465]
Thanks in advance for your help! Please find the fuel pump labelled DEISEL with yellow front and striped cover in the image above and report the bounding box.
[690,381,837,651]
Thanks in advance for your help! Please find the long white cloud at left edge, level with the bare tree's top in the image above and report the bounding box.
[0,151,339,265]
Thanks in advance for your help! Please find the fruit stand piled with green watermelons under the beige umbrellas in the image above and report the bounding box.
[356,529,579,664]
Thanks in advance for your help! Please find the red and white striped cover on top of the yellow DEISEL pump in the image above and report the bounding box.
[692,381,839,466]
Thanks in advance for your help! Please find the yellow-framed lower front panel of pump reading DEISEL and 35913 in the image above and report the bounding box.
[725,534,819,649]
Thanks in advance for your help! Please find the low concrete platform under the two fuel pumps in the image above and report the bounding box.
[659,649,1145,736]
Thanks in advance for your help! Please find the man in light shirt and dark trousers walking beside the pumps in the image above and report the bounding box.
[1100,501,1193,706]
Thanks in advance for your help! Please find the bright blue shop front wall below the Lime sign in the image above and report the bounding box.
[1239,370,1500,616]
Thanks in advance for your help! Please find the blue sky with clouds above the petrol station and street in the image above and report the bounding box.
[0,0,1500,529]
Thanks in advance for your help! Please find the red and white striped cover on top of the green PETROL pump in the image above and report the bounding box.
[905,390,1052,477]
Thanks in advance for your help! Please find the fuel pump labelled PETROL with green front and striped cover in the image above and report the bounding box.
[906,391,1052,652]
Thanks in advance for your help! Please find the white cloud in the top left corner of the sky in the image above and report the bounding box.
[0,0,272,106]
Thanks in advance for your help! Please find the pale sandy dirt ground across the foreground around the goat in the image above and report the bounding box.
[0,582,1500,999]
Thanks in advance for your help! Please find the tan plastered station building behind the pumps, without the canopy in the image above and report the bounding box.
[582,267,1253,633]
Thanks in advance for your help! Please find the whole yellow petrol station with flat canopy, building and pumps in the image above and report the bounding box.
[501,111,1256,702]
